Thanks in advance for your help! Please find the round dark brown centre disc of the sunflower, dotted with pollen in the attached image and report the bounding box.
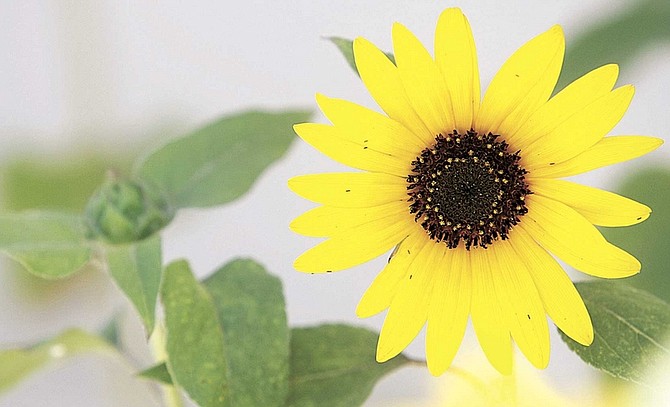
[407,130,531,250]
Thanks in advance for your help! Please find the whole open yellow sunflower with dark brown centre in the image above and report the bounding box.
[289,8,662,375]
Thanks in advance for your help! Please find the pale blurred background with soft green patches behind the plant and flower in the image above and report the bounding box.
[0,0,670,407]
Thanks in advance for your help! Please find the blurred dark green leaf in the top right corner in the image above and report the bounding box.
[556,0,670,90]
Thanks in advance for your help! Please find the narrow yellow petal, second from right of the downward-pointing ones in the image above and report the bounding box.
[489,237,549,369]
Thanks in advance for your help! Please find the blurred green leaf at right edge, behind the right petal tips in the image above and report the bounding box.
[601,167,670,303]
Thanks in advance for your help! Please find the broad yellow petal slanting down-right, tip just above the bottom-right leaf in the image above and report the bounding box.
[517,195,640,278]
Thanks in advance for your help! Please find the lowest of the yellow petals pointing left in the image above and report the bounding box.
[293,204,415,273]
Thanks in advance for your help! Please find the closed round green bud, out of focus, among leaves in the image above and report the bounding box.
[86,175,174,243]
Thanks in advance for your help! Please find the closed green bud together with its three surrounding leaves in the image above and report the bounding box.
[0,111,309,334]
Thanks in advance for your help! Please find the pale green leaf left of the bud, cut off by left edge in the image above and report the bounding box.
[0,211,91,279]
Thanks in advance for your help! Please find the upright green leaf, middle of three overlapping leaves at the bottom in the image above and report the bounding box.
[204,260,289,406]
